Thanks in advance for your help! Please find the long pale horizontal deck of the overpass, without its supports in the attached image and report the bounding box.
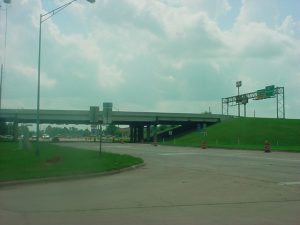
[0,109,229,124]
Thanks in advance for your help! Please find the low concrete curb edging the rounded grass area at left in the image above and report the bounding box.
[0,163,145,188]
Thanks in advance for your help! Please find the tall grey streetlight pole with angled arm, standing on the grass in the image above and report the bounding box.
[36,0,95,156]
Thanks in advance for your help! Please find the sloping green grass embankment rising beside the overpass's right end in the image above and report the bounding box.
[165,118,300,152]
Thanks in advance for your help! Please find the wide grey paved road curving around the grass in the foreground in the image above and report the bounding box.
[0,143,300,225]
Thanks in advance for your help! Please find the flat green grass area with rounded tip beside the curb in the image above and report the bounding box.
[0,142,143,182]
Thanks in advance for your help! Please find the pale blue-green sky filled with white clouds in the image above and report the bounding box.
[0,0,300,118]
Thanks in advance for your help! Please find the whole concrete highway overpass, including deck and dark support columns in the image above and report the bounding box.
[0,106,230,142]
